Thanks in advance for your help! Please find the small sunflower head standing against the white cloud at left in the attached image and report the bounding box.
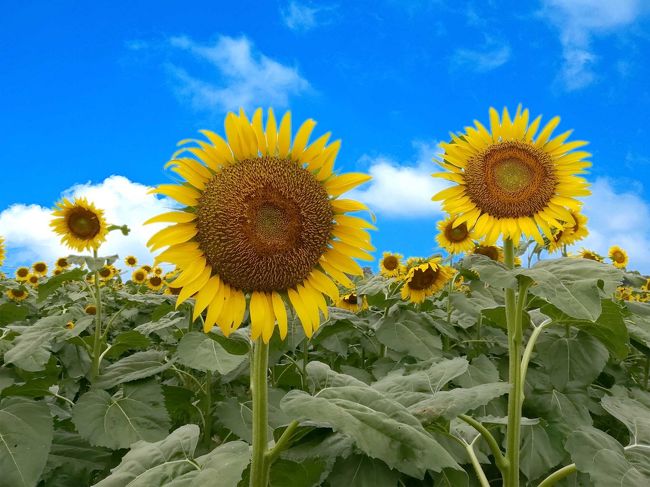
[50,198,108,252]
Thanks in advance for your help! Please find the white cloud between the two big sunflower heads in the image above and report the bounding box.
[349,142,448,219]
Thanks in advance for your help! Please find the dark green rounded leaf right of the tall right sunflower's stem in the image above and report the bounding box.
[537,332,609,391]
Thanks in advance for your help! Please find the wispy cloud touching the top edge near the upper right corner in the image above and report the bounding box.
[542,0,642,91]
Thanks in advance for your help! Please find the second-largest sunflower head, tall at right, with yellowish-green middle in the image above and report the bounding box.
[433,106,591,245]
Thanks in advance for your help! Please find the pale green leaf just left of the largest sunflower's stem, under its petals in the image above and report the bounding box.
[176,331,248,375]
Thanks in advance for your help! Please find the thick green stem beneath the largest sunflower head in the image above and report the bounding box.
[250,338,270,487]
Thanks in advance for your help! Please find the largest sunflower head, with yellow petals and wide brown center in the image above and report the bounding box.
[148,109,374,342]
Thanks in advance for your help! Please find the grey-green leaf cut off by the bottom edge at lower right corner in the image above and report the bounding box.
[565,427,650,487]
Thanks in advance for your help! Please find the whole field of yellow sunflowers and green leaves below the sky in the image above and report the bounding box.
[0,107,650,487]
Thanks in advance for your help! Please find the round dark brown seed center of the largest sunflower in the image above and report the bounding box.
[196,157,333,291]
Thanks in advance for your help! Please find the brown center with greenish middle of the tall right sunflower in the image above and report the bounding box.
[465,141,557,218]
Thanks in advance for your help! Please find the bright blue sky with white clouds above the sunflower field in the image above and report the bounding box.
[0,0,650,272]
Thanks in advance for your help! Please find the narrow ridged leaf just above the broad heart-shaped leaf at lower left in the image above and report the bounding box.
[94,350,172,389]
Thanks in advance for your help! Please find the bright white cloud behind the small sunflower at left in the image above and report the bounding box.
[0,176,173,268]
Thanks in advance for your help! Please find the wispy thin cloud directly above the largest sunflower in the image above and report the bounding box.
[170,36,309,112]
